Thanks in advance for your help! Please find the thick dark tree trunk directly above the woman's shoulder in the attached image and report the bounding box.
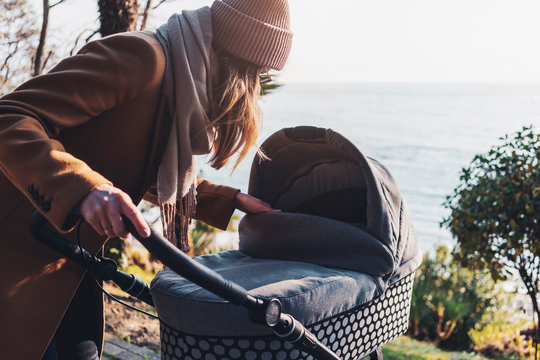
[98,0,139,36]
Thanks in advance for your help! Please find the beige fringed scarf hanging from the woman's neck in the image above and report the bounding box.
[156,7,213,251]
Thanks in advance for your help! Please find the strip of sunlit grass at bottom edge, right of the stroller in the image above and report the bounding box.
[383,336,519,360]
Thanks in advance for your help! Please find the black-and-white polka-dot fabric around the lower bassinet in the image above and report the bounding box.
[161,274,414,360]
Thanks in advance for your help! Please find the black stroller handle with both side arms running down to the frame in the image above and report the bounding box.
[30,211,340,360]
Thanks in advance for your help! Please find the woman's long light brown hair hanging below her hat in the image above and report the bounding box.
[210,49,263,169]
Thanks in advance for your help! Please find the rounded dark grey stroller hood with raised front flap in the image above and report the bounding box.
[239,126,421,282]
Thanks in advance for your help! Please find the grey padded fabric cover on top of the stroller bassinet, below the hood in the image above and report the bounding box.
[151,250,382,336]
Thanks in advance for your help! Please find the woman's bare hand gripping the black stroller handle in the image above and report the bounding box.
[80,184,150,237]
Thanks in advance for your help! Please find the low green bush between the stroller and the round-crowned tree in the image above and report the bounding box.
[410,246,502,350]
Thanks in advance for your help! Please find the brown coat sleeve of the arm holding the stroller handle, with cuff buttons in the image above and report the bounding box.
[0,35,163,231]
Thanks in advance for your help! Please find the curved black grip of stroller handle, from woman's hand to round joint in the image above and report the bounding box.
[122,216,263,311]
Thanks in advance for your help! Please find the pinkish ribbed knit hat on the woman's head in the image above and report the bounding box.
[211,0,292,70]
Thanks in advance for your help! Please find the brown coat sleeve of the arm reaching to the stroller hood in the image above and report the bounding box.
[144,179,240,230]
